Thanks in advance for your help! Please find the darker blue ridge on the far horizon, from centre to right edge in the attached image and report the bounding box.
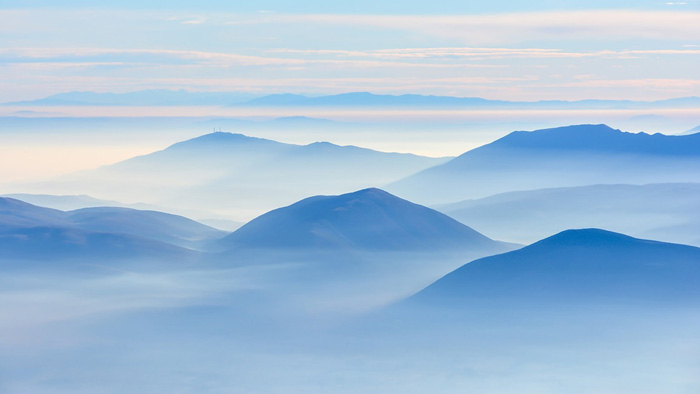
[236,92,700,109]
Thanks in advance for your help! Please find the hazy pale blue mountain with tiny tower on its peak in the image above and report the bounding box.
[32,132,448,221]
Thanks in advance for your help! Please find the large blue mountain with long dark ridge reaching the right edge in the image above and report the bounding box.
[386,125,700,204]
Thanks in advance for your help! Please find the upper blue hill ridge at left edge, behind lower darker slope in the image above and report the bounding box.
[0,198,226,248]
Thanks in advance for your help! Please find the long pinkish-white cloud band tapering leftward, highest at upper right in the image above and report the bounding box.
[260,10,700,44]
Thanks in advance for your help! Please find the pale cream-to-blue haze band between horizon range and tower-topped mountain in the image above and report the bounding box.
[0,106,700,183]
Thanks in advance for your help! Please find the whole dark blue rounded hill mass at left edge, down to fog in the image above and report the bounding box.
[0,198,221,259]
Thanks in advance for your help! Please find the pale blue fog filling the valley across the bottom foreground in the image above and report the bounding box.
[0,252,700,393]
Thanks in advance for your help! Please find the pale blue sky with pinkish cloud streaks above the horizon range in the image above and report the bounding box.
[0,0,700,102]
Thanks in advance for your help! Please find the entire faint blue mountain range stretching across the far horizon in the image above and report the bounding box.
[4,90,700,109]
